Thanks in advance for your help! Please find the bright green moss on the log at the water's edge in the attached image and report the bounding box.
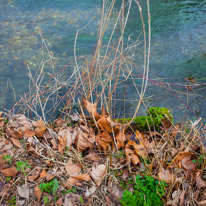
[116,107,173,131]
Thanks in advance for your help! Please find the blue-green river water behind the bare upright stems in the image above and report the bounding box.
[0,0,206,121]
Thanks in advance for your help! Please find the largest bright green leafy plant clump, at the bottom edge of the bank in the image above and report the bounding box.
[120,175,167,206]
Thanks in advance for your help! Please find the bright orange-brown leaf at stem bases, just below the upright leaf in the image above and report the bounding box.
[97,115,120,133]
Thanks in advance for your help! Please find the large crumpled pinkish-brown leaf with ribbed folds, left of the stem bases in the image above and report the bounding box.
[75,128,95,152]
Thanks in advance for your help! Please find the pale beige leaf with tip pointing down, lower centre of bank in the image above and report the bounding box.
[91,164,107,187]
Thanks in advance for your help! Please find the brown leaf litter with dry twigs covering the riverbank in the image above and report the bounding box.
[0,99,206,205]
